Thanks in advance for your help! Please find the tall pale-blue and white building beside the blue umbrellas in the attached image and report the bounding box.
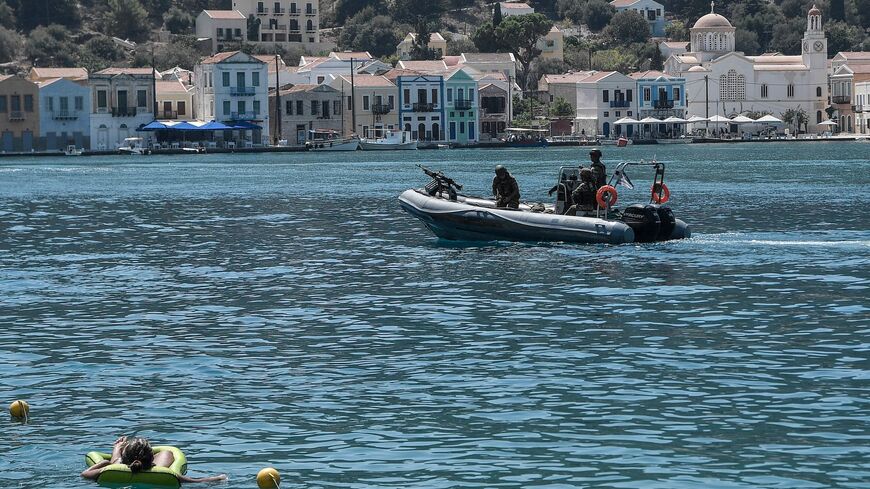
[193,51,269,146]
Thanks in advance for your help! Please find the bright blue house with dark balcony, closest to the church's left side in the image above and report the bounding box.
[629,71,687,136]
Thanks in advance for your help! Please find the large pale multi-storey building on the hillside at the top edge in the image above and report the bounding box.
[232,0,333,53]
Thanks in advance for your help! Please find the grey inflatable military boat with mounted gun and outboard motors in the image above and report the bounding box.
[399,162,691,244]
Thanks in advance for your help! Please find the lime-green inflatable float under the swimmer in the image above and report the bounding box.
[85,446,187,487]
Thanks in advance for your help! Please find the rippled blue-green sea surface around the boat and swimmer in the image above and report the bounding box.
[0,143,870,489]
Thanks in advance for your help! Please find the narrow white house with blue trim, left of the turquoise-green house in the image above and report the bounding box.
[396,70,445,141]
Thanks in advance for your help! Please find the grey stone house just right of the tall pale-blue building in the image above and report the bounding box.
[269,84,342,144]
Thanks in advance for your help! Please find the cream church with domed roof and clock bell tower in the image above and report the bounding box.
[665,3,828,132]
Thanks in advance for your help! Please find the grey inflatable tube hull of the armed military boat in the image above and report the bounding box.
[399,189,652,244]
